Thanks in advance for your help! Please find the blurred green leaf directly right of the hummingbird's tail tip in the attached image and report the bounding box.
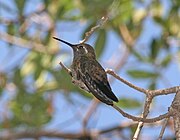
[117,98,141,109]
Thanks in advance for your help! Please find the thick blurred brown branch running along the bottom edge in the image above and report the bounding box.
[0,122,167,140]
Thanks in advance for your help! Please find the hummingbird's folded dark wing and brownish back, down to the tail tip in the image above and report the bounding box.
[79,60,118,105]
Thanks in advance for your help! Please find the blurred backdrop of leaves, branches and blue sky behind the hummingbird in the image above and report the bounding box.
[0,0,180,140]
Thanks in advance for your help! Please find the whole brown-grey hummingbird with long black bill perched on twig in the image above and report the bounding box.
[53,37,118,106]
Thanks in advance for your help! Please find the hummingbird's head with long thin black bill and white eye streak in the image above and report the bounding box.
[53,37,96,59]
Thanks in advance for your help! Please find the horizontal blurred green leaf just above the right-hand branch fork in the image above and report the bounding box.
[127,70,158,79]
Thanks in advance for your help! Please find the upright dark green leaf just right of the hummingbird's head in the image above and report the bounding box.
[95,30,106,58]
